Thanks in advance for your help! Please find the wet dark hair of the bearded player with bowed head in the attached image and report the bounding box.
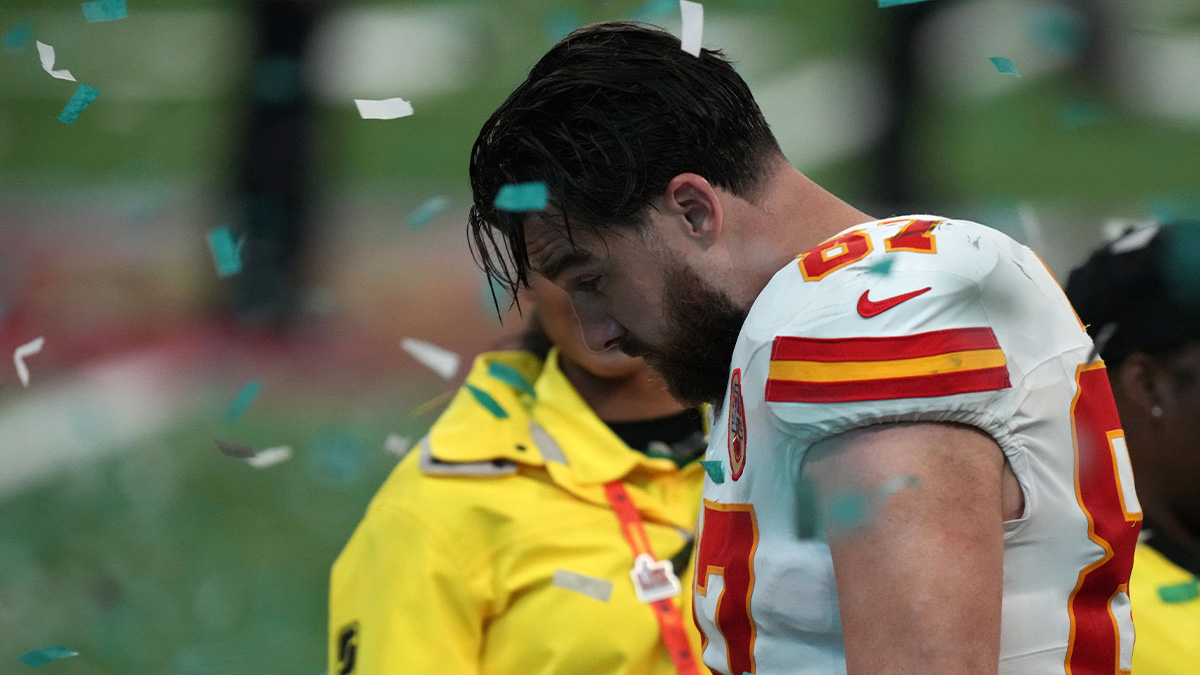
[469,22,782,303]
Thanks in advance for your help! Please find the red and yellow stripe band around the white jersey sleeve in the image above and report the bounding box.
[767,328,1010,404]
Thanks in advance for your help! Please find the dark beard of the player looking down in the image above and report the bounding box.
[620,261,748,407]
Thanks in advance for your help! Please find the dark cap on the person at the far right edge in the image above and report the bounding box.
[1067,221,1200,370]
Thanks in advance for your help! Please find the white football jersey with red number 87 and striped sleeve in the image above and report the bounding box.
[695,215,1141,675]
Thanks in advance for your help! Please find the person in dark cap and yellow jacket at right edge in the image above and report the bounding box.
[1067,221,1200,675]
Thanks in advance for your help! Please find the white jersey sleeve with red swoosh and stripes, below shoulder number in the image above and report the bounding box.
[751,241,1036,447]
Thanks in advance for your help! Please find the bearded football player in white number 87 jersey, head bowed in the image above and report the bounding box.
[470,23,1141,675]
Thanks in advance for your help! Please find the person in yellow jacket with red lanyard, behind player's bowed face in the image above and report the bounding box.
[329,275,710,675]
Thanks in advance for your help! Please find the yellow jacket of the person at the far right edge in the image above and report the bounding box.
[1129,544,1200,675]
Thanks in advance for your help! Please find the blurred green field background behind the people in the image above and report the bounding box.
[0,0,1200,675]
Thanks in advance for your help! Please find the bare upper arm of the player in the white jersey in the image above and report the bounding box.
[805,424,1004,675]
